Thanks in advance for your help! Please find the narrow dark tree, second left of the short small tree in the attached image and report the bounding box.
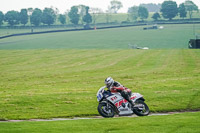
[31,8,42,26]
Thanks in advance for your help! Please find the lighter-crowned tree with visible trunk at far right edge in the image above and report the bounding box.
[184,0,198,19]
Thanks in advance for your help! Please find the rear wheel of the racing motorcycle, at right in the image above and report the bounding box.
[133,100,150,116]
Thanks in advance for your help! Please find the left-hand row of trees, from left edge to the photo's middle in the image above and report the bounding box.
[0,5,92,26]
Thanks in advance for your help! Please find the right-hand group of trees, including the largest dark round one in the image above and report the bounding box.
[128,0,199,21]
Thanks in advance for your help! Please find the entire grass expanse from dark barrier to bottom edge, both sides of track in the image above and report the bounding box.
[0,24,200,133]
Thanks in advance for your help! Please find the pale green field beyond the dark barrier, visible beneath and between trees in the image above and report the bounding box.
[0,12,200,36]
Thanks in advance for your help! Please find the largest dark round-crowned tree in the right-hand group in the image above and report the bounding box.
[160,1,178,20]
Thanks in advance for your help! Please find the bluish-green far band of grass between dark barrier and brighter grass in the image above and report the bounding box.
[0,24,200,49]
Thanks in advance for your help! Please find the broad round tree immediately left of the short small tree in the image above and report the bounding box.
[42,8,56,25]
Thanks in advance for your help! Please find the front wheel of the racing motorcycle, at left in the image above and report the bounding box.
[97,103,115,118]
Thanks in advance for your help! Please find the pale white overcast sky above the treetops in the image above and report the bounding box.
[0,0,200,13]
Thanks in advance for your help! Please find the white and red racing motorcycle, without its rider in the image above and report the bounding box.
[97,86,150,118]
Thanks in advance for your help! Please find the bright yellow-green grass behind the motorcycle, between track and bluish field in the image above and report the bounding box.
[0,49,200,119]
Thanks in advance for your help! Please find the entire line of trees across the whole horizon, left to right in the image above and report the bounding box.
[0,0,198,26]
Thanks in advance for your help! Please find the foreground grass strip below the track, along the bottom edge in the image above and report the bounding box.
[0,112,200,133]
